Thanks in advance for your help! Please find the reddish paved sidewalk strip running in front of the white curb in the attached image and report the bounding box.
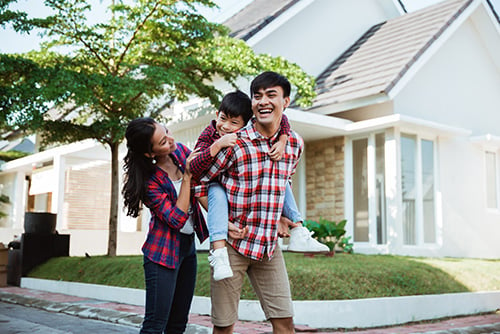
[0,286,500,334]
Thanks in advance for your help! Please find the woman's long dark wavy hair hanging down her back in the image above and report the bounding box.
[122,117,156,217]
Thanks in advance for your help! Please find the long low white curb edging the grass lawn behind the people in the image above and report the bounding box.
[21,277,500,329]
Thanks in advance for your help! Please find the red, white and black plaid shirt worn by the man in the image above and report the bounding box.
[197,120,304,260]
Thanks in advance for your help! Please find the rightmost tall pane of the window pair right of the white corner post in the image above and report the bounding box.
[422,140,436,243]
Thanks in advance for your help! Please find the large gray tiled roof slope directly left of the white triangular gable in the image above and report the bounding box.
[311,0,473,109]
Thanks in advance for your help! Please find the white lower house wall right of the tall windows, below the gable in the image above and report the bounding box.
[439,137,500,258]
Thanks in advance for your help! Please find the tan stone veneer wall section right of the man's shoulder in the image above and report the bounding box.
[306,137,345,222]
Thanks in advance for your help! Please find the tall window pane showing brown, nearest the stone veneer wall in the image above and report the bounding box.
[352,139,368,242]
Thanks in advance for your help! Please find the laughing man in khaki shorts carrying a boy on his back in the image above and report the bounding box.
[198,72,304,333]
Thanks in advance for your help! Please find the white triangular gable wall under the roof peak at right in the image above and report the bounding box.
[394,16,500,135]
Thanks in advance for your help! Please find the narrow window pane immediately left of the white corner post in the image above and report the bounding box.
[375,133,387,245]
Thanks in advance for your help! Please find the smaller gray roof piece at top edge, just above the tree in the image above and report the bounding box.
[223,0,300,41]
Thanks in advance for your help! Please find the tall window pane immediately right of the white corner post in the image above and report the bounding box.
[401,135,416,245]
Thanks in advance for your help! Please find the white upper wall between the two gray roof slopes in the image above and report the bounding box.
[248,0,400,76]
